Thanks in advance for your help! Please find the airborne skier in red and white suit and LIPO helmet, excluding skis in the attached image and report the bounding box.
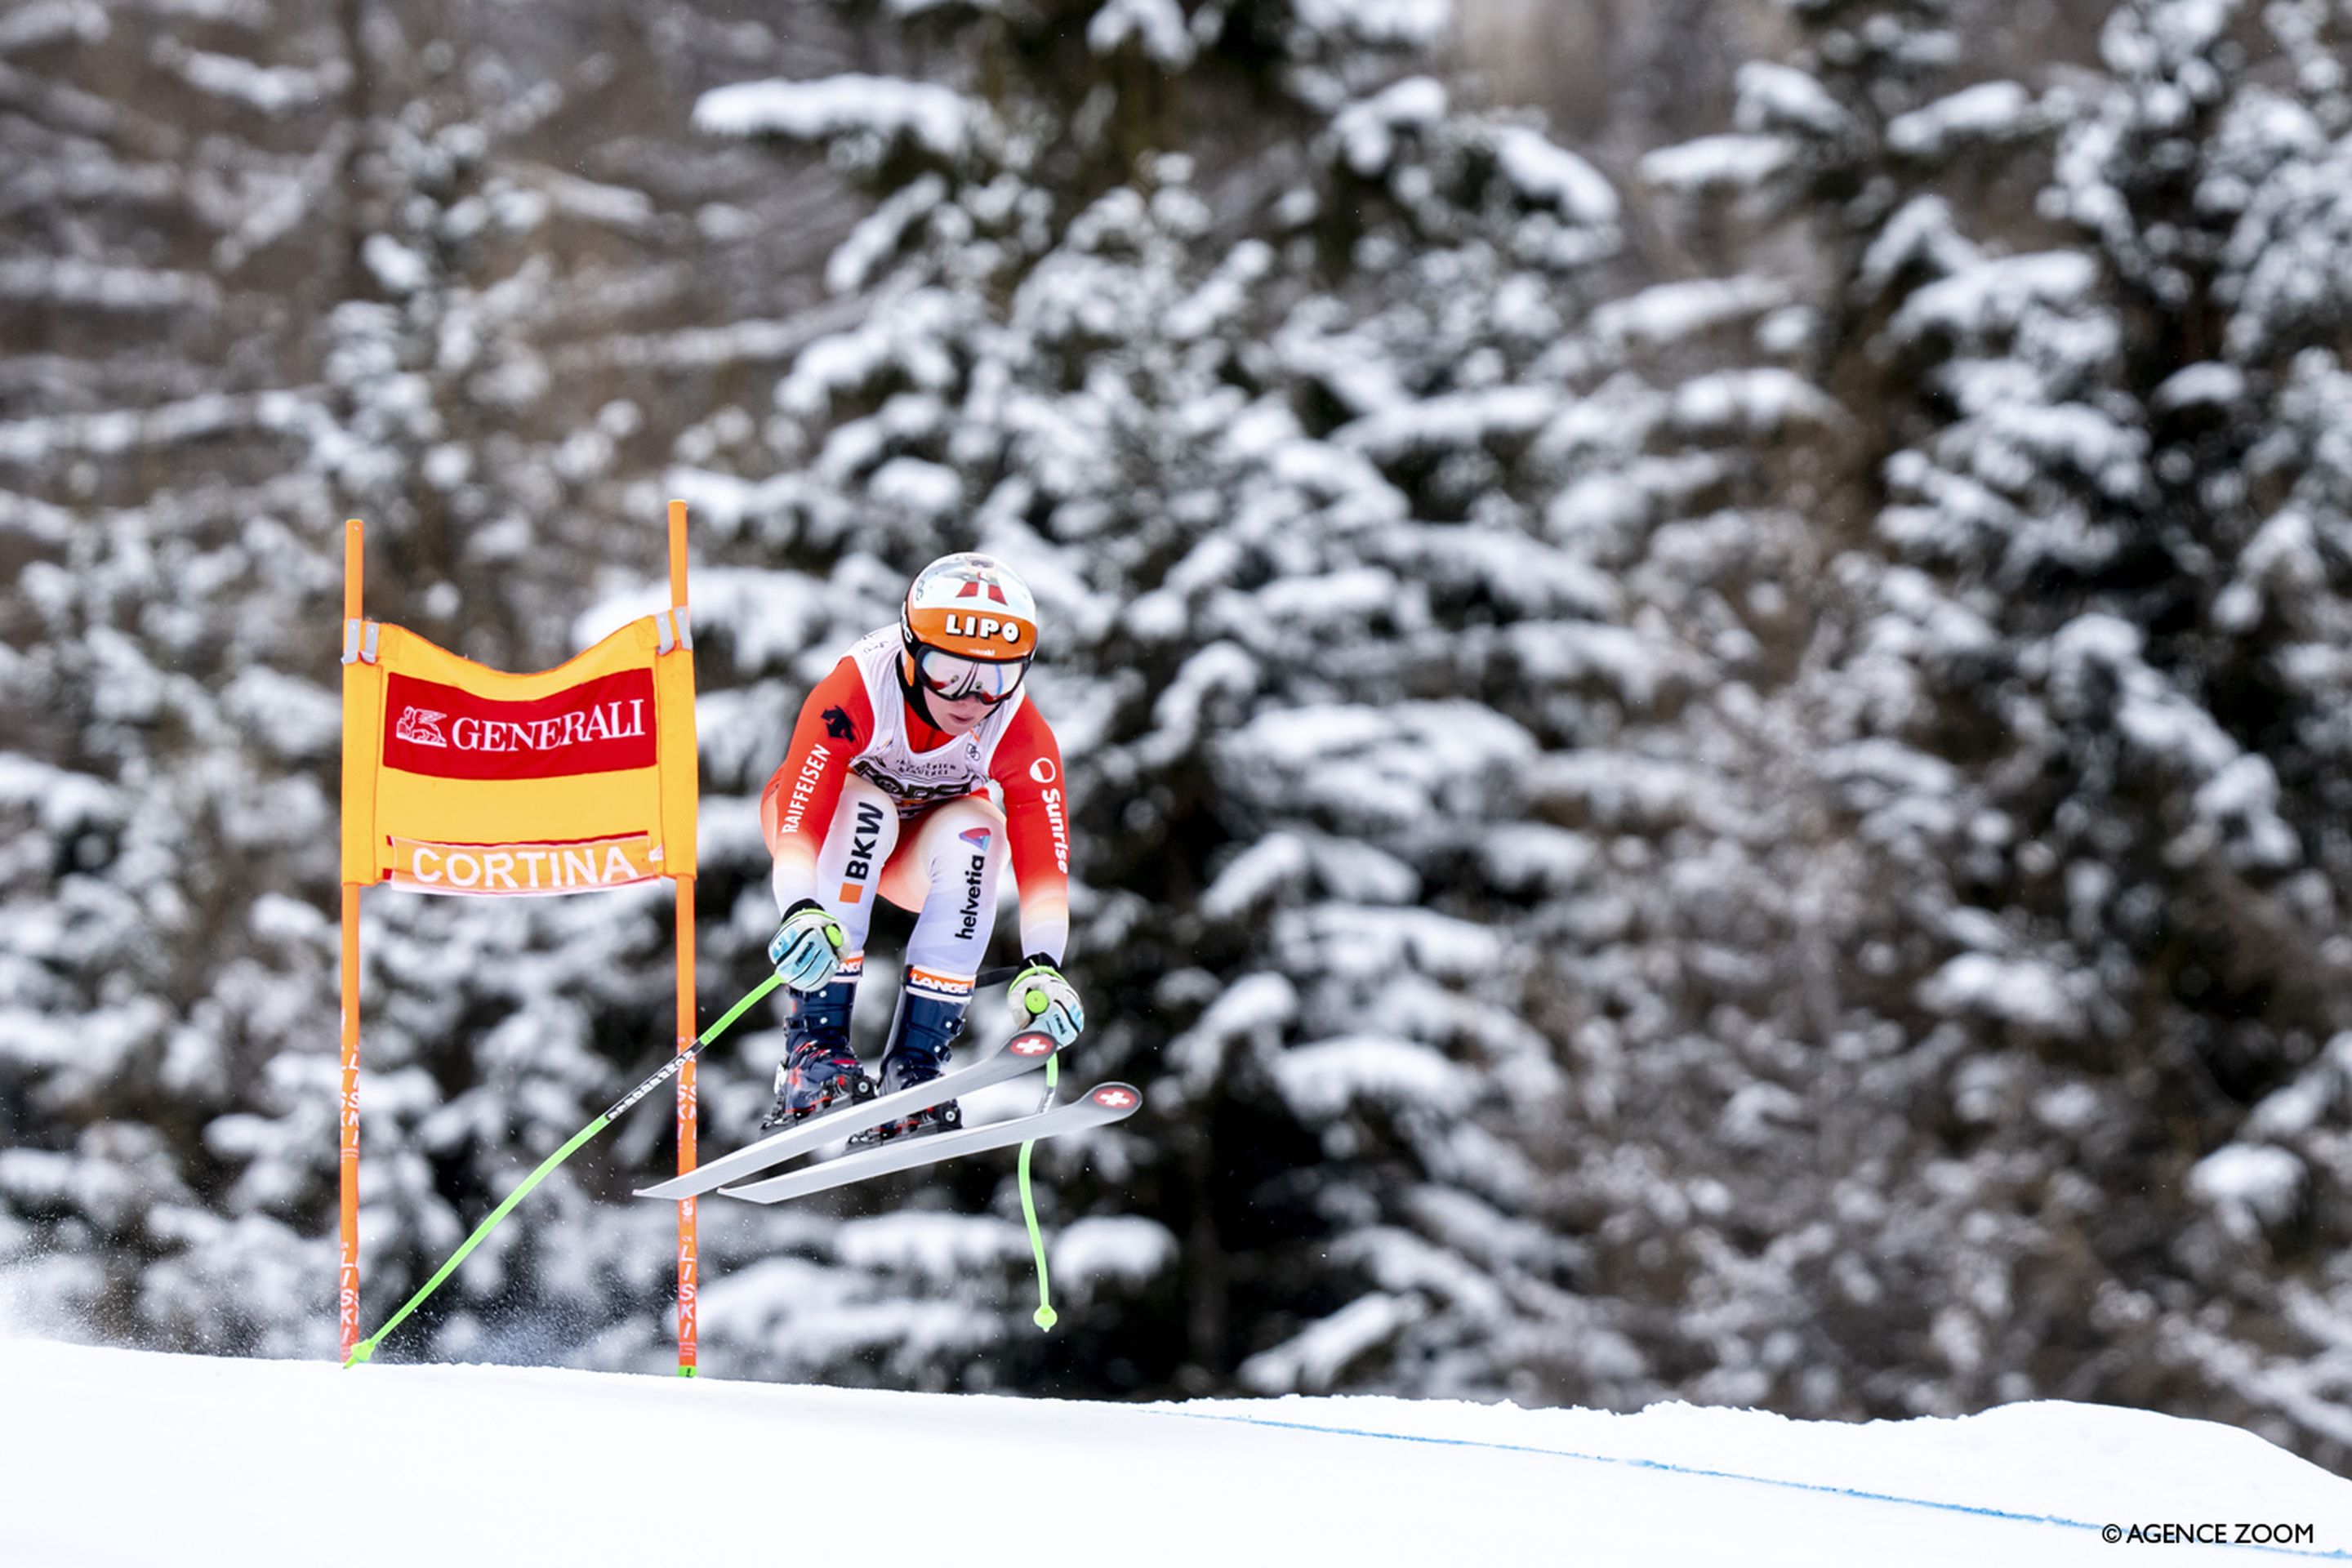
[760,555,1087,1138]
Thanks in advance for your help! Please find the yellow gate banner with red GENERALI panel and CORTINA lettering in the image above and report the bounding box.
[343,611,696,893]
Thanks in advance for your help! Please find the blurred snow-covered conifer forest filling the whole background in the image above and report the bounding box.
[0,0,2352,1469]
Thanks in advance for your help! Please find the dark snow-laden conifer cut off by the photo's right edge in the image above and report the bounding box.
[2048,2,2352,1464]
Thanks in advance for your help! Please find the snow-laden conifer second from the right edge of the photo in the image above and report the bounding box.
[1655,5,2147,1413]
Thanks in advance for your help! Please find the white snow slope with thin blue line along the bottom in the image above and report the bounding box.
[0,1340,2352,1568]
